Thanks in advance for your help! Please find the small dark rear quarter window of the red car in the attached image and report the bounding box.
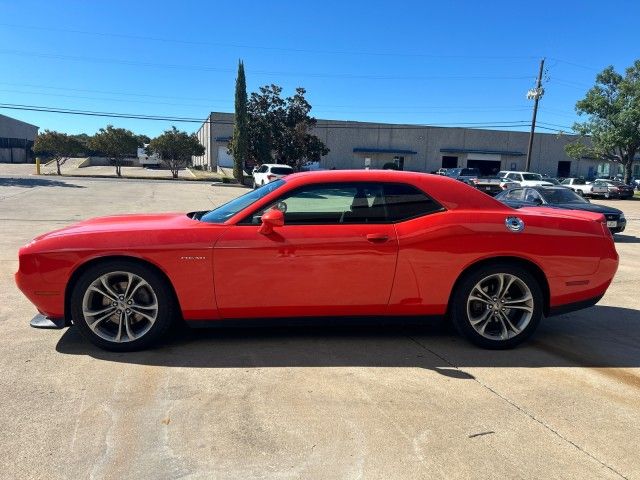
[382,183,443,222]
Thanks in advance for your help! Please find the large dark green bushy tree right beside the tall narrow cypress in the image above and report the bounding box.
[242,84,329,168]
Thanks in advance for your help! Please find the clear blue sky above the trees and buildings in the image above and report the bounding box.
[0,0,640,136]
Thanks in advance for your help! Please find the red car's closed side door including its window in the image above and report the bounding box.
[213,182,398,318]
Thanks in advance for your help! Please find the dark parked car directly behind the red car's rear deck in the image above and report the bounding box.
[495,186,627,233]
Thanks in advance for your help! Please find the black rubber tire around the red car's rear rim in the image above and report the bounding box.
[450,263,544,349]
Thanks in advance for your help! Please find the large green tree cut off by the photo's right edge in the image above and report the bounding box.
[565,60,640,183]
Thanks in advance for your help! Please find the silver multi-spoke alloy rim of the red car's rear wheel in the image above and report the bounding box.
[467,273,534,340]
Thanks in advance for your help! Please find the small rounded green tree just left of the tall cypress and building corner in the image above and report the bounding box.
[147,127,204,178]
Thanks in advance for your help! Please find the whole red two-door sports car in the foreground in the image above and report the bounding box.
[16,170,618,351]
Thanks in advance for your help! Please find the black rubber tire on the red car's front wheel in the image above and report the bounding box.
[71,260,177,352]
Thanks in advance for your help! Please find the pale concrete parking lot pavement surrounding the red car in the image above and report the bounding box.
[0,175,640,479]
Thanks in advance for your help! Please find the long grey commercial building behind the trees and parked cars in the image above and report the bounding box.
[194,112,636,177]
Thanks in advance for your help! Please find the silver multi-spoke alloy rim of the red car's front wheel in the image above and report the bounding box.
[82,272,158,343]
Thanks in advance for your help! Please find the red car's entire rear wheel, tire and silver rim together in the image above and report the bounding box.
[451,264,543,349]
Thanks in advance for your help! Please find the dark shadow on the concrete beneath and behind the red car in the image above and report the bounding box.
[56,306,640,376]
